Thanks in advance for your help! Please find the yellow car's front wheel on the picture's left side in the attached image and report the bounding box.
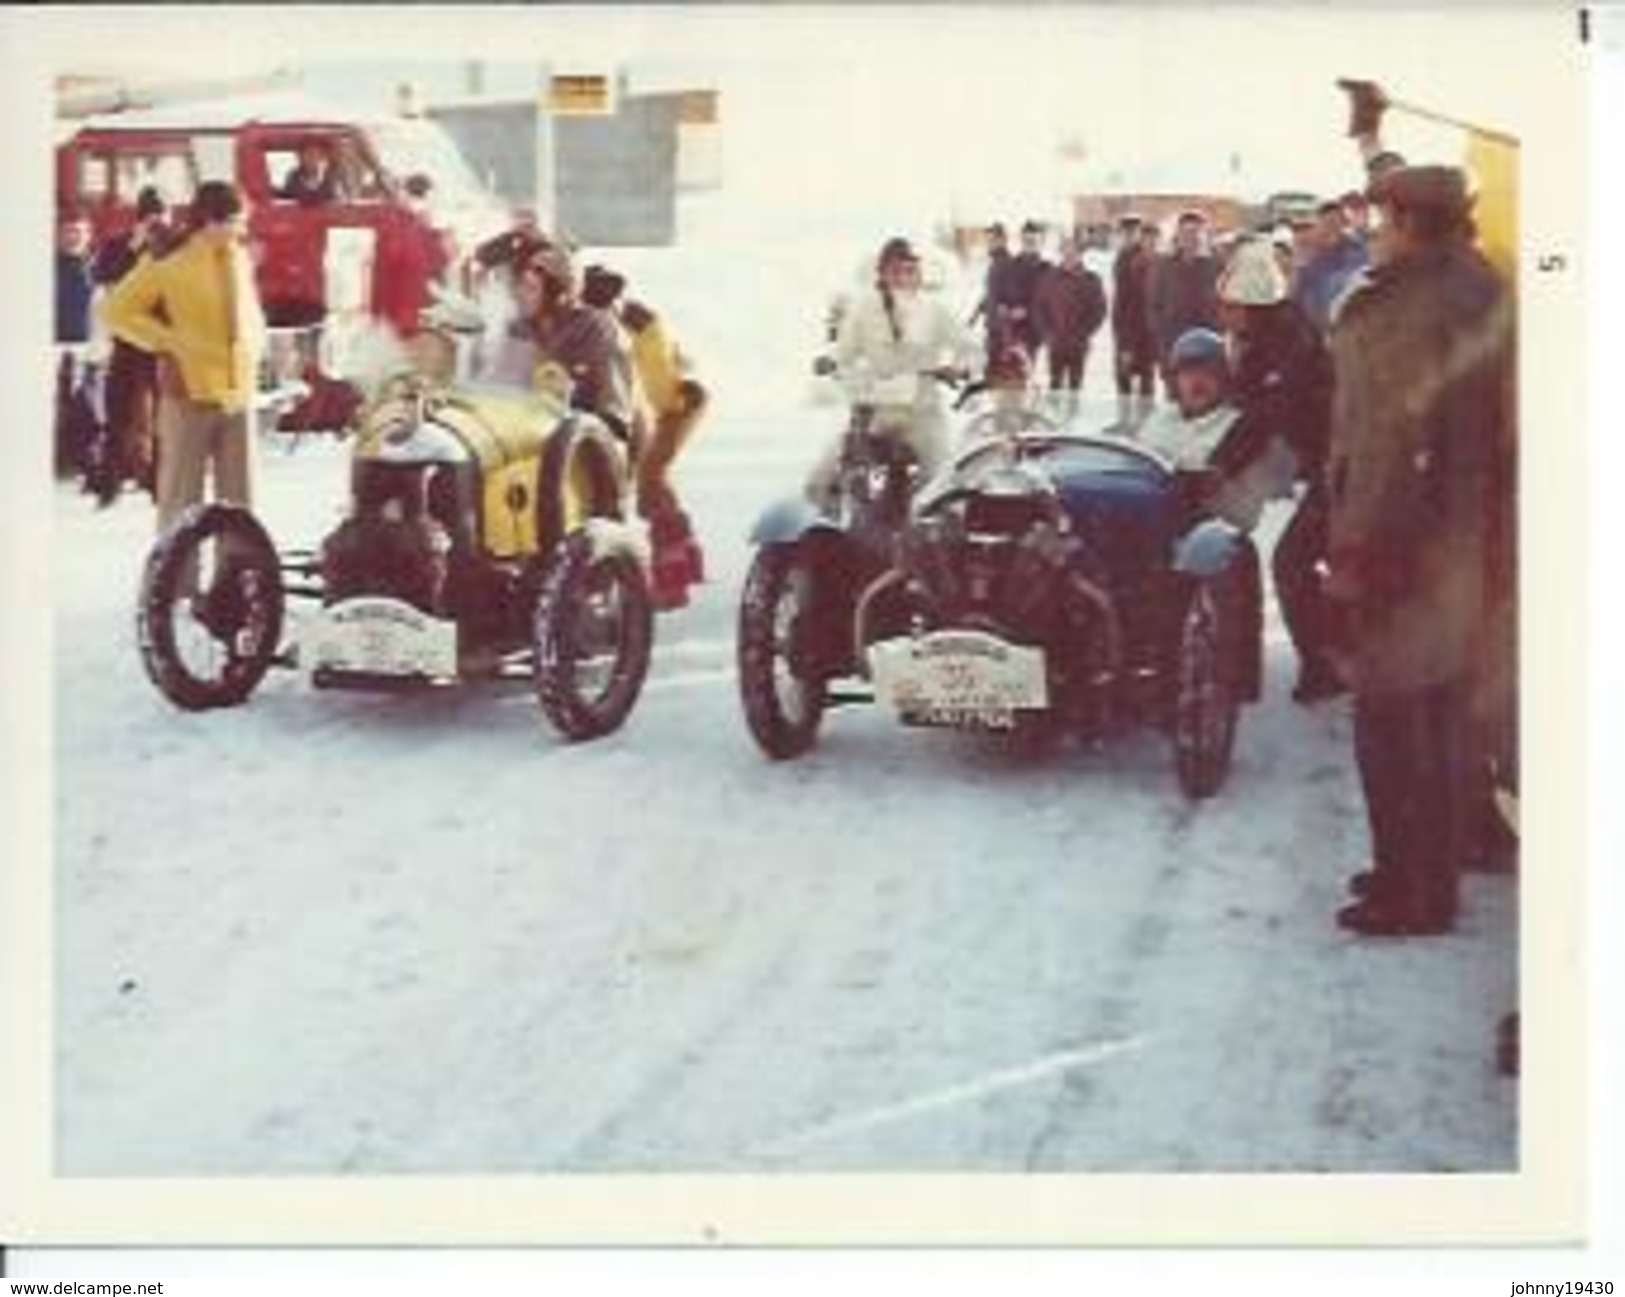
[137,504,283,712]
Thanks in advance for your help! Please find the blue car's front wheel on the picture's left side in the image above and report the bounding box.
[738,544,829,761]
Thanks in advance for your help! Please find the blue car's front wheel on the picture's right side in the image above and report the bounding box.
[1173,580,1240,798]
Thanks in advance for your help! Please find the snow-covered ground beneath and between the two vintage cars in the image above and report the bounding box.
[55,238,1518,1175]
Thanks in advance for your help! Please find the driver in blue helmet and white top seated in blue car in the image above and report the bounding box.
[1139,328,1294,531]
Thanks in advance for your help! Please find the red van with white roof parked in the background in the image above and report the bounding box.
[57,91,507,332]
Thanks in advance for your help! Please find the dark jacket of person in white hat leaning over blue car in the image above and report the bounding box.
[1220,302,1333,481]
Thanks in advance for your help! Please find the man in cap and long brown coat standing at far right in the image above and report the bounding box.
[1328,166,1516,936]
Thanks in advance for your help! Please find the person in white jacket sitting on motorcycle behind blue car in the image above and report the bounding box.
[806,239,980,509]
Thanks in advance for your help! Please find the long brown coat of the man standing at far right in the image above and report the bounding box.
[1328,244,1516,696]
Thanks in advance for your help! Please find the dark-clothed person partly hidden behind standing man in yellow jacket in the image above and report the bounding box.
[86,185,174,507]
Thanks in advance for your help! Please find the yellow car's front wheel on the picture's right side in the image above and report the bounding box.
[531,531,655,741]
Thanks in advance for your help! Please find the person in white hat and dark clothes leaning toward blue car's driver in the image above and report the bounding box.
[1219,239,1346,704]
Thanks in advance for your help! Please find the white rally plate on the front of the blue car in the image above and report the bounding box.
[869,631,1050,728]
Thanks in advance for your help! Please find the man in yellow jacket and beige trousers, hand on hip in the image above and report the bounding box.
[102,180,265,531]
